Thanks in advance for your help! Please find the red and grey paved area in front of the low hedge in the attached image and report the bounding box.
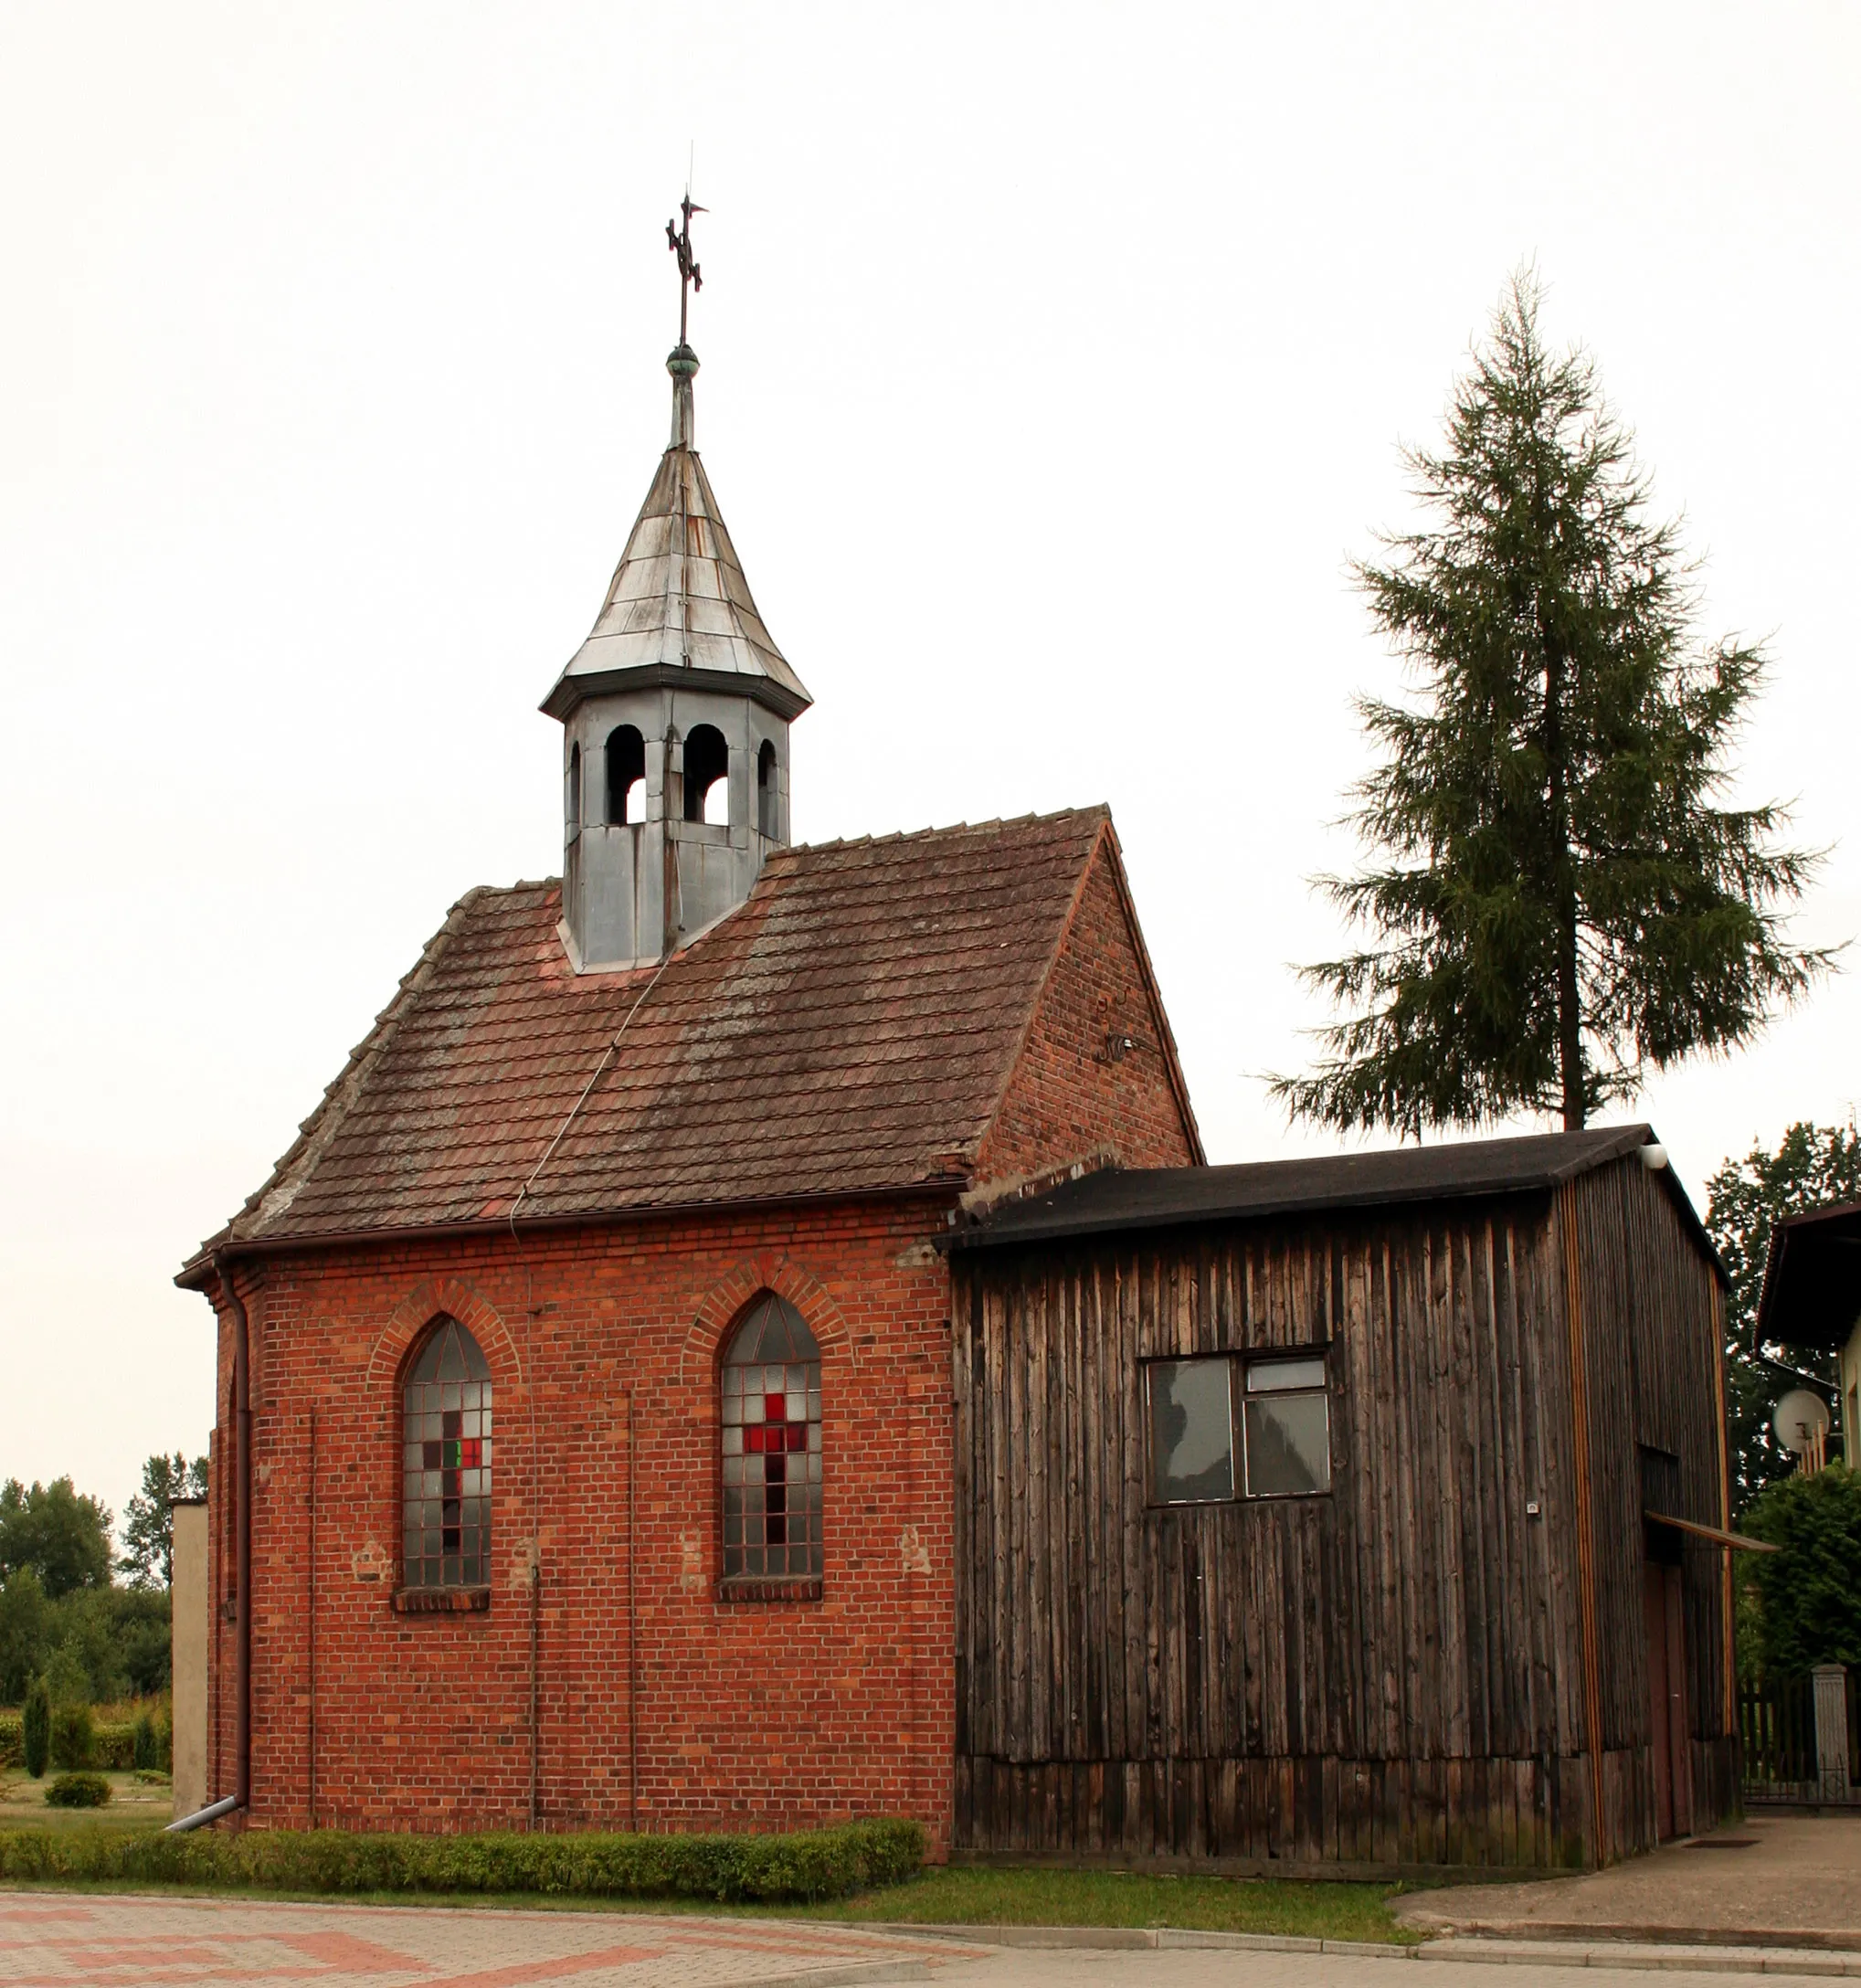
[0,1893,982,1988]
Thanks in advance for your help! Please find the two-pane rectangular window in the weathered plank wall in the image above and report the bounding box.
[1143,1354,1330,1505]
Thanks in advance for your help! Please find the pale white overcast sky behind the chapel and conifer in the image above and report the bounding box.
[0,0,1861,1534]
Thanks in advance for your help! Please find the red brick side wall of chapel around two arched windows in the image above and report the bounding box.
[213,1200,955,1843]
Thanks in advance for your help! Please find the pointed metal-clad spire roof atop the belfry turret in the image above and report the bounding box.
[528,344,813,718]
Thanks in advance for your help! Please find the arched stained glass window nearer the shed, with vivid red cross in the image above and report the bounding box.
[724,1292,821,1579]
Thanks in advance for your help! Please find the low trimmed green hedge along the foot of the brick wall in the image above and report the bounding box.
[0,1817,925,1900]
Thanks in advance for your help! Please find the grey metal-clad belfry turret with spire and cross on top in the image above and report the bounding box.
[543,199,813,972]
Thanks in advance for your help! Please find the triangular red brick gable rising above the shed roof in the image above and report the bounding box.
[977,839,1200,1181]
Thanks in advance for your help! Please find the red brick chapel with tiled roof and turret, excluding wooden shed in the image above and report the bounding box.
[179,288,1203,1849]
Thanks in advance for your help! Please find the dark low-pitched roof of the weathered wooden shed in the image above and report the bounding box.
[950,1126,1710,1253]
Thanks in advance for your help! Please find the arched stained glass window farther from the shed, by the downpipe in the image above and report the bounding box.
[402,1318,492,1589]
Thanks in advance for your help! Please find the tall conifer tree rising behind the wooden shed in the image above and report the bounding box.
[1274,272,1827,1137]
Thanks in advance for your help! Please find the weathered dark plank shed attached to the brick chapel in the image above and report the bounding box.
[950,1126,1738,1875]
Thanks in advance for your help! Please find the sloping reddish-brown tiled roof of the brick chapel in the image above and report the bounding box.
[181,807,1179,1285]
